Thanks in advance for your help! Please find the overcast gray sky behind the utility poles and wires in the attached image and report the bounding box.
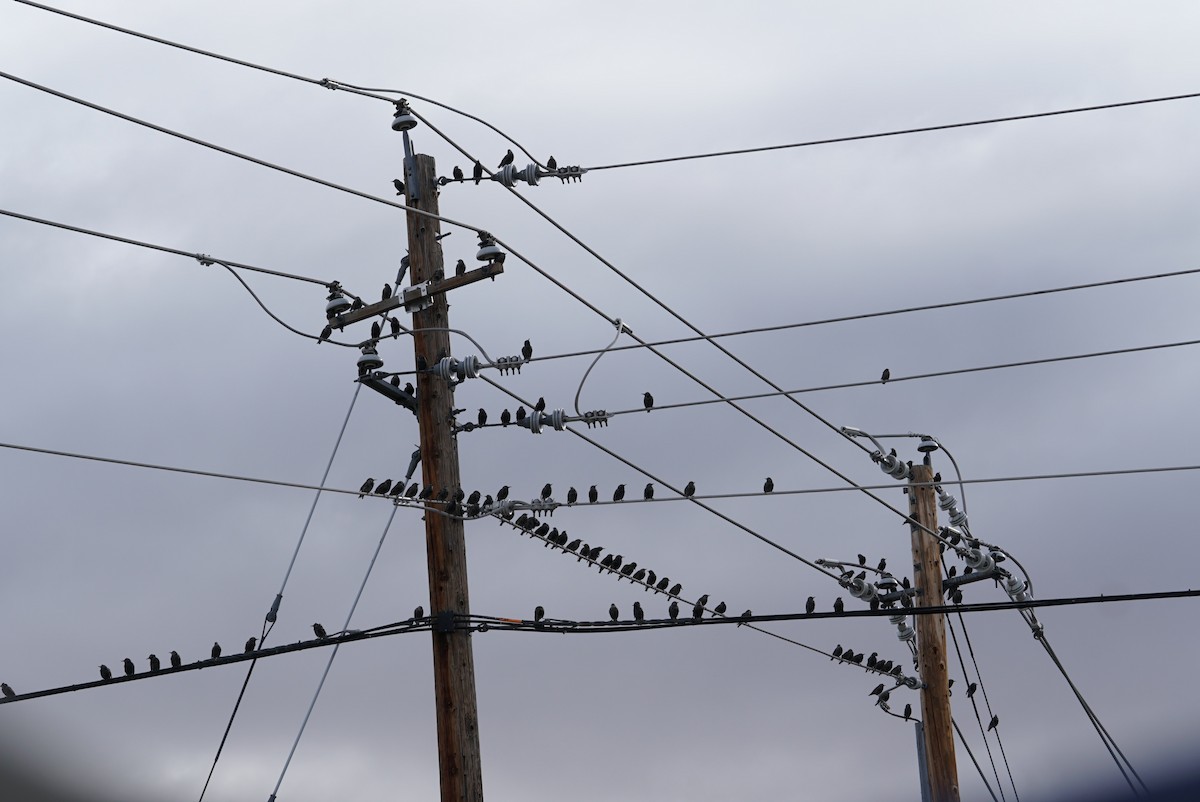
[0,0,1200,802]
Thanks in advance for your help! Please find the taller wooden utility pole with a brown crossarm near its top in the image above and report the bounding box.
[405,151,484,802]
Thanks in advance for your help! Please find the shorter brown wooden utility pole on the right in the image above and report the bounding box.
[908,465,959,802]
